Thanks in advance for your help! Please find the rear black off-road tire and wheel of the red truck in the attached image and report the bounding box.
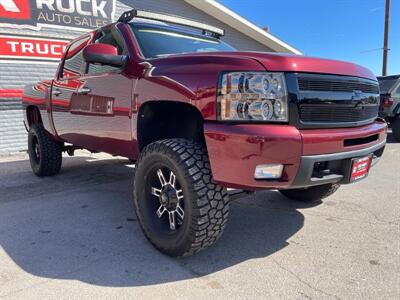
[28,124,62,177]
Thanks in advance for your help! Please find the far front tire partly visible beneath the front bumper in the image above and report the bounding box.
[280,183,340,203]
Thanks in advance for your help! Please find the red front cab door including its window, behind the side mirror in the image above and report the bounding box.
[71,25,137,157]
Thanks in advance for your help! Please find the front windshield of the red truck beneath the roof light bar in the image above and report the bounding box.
[130,23,235,58]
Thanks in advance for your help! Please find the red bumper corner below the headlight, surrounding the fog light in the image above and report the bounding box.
[204,123,302,189]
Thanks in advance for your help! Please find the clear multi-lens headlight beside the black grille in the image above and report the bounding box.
[218,72,288,122]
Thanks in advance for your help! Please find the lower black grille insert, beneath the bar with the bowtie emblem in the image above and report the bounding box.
[300,104,378,123]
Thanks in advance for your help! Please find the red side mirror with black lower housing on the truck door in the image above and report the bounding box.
[82,44,126,67]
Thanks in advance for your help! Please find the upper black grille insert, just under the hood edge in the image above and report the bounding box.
[297,77,379,94]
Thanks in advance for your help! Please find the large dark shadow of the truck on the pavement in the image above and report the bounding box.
[0,157,310,286]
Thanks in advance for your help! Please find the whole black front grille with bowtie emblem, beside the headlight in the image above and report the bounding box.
[296,74,379,128]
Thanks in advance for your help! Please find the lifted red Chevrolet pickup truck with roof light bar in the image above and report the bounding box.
[23,10,387,256]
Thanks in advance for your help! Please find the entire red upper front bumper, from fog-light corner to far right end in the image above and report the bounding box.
[204,121,387,189]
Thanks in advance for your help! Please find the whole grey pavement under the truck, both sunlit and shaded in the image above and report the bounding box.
[0,134,400,299]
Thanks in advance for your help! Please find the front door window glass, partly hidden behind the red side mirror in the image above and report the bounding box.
[87,28,127,74]
